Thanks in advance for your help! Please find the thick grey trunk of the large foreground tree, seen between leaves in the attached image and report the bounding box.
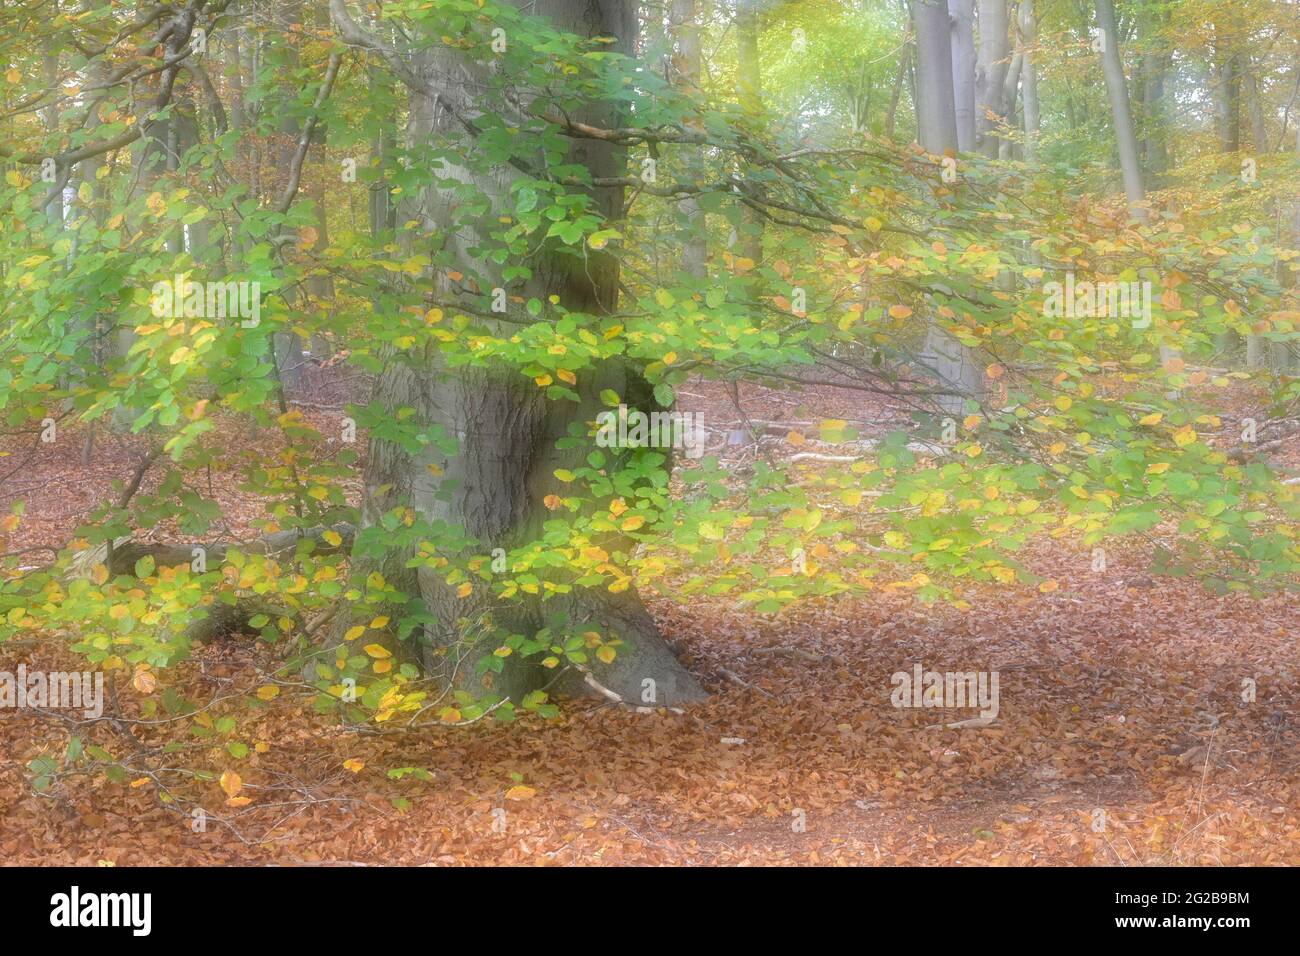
[333,0,703,705]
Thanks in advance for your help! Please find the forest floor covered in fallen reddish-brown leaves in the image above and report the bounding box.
[0,374,1300,865]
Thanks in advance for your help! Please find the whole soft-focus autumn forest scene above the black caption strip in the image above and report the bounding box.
[0,0,1300,864]
